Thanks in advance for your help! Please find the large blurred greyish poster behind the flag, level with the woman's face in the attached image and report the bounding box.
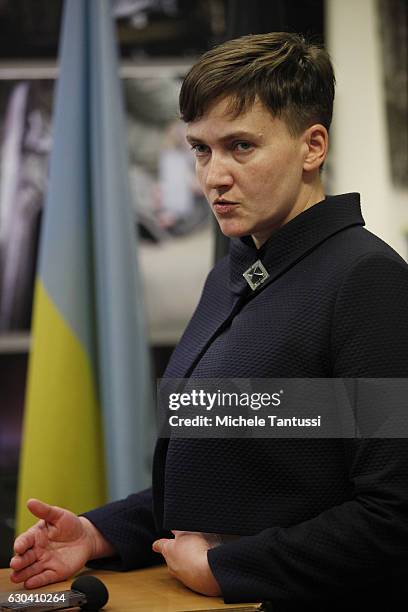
[0,77,212,344]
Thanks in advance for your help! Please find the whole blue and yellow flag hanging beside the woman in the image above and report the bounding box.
[17,0,151,532]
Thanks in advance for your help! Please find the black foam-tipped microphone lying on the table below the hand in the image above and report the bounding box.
[0,576,109,612]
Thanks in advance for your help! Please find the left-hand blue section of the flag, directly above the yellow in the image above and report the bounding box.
[39,1,93,357]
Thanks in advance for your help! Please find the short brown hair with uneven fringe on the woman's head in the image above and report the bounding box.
[180,32,335,135]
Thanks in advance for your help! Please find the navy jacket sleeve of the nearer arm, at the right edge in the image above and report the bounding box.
[208,254,408,610]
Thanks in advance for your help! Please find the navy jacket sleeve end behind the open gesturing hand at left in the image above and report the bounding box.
[82,489,169,571]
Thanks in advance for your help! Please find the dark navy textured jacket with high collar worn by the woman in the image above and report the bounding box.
[86,194,408,609]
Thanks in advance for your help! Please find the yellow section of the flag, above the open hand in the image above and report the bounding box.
[16,280,106,533]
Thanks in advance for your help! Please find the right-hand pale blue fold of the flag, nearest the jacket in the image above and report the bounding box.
[89,0,153,499]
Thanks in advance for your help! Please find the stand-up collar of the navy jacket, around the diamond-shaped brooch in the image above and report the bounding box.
[229,193,365,295]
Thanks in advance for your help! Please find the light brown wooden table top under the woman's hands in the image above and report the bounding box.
[0,566,261,612]
